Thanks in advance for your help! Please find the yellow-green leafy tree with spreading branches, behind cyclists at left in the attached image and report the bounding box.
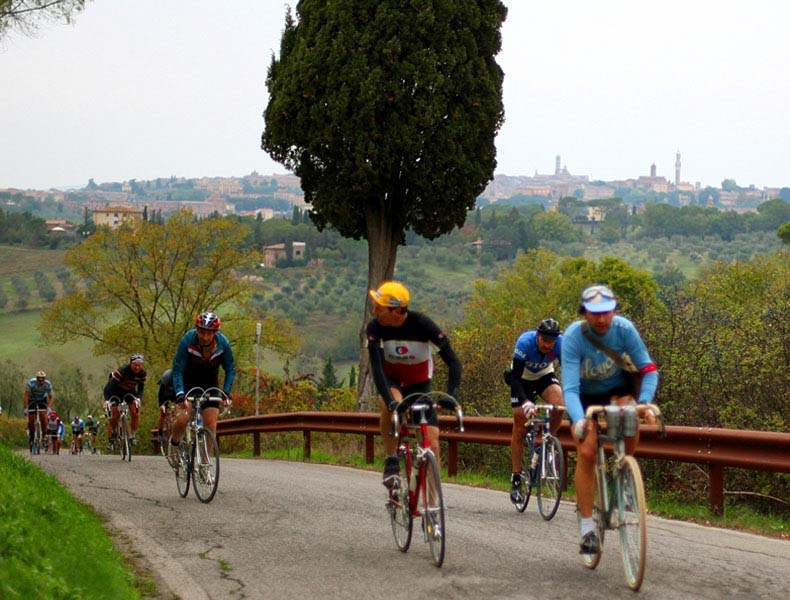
[40,212,293,371]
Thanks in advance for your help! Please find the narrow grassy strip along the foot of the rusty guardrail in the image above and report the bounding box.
[227,447,790,539]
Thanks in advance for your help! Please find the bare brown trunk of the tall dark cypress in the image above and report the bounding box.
[357,206,402,411]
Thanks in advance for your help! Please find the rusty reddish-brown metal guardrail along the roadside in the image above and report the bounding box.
[210,412,790,512]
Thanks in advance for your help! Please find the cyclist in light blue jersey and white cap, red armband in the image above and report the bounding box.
[562,285,658,554]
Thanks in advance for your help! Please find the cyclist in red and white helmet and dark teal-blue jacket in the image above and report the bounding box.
[172,311,236,449]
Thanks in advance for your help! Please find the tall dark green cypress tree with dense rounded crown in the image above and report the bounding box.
[261,0,507,404]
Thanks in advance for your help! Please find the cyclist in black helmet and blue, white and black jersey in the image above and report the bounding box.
[508,318,563,504]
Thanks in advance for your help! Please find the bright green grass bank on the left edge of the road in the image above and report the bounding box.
[0,445,140,600]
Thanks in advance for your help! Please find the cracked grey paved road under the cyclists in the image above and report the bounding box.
[33,455,790,600]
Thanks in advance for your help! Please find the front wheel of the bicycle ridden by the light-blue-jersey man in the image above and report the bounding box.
[615,456,647,590]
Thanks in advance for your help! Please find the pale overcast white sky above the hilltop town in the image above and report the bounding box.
[0,0,790,189]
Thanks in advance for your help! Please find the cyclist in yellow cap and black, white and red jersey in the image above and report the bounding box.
[366,281,461,487]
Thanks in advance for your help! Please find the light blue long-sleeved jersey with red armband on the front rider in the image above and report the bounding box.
[562,315,658,423]
